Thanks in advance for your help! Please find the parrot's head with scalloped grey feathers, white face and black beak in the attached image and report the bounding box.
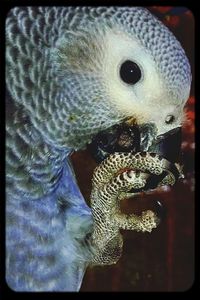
[50,7,191,176]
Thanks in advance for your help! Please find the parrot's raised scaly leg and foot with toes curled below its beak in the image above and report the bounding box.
[90,153,181,265]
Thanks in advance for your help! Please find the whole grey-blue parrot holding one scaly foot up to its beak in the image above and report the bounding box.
[5,6,192,291]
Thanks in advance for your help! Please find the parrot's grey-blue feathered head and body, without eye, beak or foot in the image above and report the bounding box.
[6,7,191,291]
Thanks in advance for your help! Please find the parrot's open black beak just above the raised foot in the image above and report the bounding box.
[88,123,181,163]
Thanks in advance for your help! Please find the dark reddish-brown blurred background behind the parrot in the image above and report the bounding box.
[72,6,195,291]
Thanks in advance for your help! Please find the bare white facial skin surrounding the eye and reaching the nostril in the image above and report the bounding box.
[103,31,185,132]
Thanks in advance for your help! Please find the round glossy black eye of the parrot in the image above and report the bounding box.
[119,60,142,84]
